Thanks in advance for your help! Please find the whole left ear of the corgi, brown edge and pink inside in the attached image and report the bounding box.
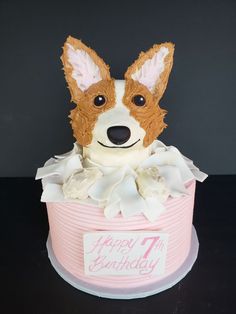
[61,36,111,103]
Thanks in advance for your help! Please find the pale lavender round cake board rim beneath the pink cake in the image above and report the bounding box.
[47,226,199,299]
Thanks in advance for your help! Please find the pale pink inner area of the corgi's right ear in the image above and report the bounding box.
[131,47,169,92]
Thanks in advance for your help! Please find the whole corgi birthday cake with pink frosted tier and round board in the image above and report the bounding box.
[36,36,207,298]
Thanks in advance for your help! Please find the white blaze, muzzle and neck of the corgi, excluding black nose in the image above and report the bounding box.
[83,80,150,168]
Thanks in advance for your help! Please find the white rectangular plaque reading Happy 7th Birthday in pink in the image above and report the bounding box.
[84,232,168,276]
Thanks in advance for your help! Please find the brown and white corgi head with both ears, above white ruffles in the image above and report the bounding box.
[61,36,174,167]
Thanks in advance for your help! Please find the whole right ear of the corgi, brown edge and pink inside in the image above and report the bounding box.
[125,43,174,100]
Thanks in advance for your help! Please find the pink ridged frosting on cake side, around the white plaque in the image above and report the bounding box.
[47,181,195,288]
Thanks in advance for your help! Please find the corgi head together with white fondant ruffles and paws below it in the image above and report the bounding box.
[37,37,206,221]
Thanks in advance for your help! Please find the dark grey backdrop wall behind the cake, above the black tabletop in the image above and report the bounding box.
[0,0,236,176]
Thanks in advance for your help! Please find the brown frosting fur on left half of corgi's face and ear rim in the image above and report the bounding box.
[61,36,115,146]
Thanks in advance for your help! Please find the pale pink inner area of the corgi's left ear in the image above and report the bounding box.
[67,44,102,91]
